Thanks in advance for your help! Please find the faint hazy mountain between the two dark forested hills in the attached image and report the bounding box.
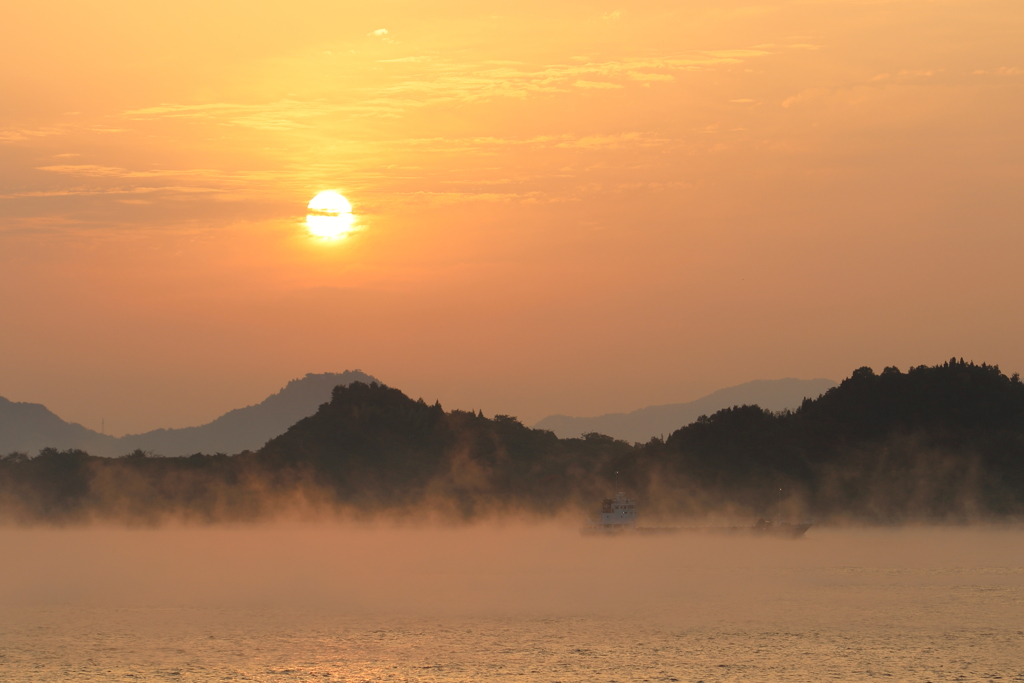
[534,378,838,443]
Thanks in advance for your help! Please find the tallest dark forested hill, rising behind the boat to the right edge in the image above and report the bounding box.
[637,358,1024,520]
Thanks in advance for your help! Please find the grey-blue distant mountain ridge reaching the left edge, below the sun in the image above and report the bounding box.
[0,370,378,457]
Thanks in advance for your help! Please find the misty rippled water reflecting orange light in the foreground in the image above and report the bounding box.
[0,524,1024,683]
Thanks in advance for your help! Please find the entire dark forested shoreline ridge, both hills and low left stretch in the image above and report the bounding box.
[0,359,1024,522]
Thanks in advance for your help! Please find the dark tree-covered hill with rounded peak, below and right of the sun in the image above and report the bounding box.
[254,384,632,515]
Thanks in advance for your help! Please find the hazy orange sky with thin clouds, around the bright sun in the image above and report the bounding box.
[0,0,1024,434]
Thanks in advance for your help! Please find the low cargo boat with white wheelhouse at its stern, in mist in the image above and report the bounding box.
[580,492,812,539]
